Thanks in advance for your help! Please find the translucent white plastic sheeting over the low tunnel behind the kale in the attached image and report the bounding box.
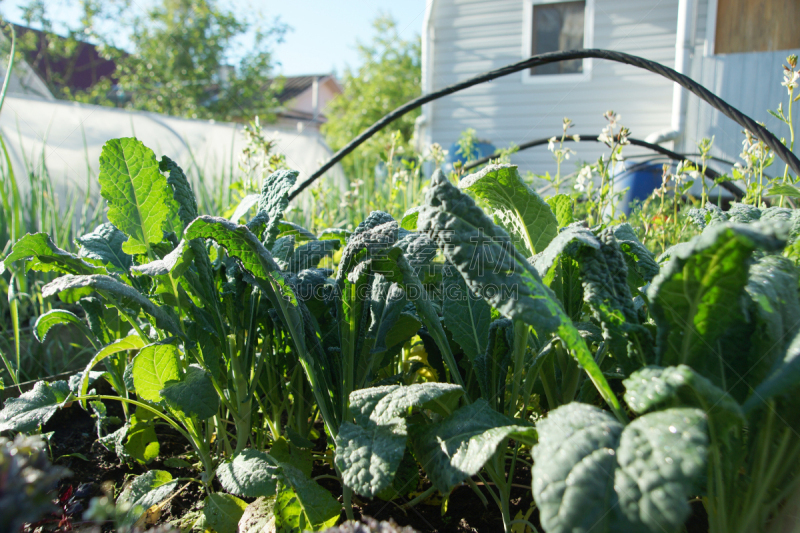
[0,95,346,206]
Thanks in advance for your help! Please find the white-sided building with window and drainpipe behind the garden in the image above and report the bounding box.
[420,0,800,179]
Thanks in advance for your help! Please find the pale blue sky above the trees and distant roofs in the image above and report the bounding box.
[0,0,429,76]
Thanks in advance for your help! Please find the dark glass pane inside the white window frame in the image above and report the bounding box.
[531,2,586,75]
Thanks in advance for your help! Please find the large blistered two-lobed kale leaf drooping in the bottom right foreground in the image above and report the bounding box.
[532,403,708,533]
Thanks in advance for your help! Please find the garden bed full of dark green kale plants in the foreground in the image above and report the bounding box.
[0,53,800,533]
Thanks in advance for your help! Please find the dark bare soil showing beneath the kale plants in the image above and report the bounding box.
[34,401,708,533]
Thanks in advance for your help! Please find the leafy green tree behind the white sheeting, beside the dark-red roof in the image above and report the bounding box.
[5,0,287,121]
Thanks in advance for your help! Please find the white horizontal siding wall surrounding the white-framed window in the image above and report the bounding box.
[428,0,678,179]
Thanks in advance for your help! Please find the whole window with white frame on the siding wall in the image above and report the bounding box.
[522,0,594,83]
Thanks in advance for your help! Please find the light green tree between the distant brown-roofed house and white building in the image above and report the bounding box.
[322,16,422,171]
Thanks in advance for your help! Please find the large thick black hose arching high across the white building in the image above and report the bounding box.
[289,49,800,200]
